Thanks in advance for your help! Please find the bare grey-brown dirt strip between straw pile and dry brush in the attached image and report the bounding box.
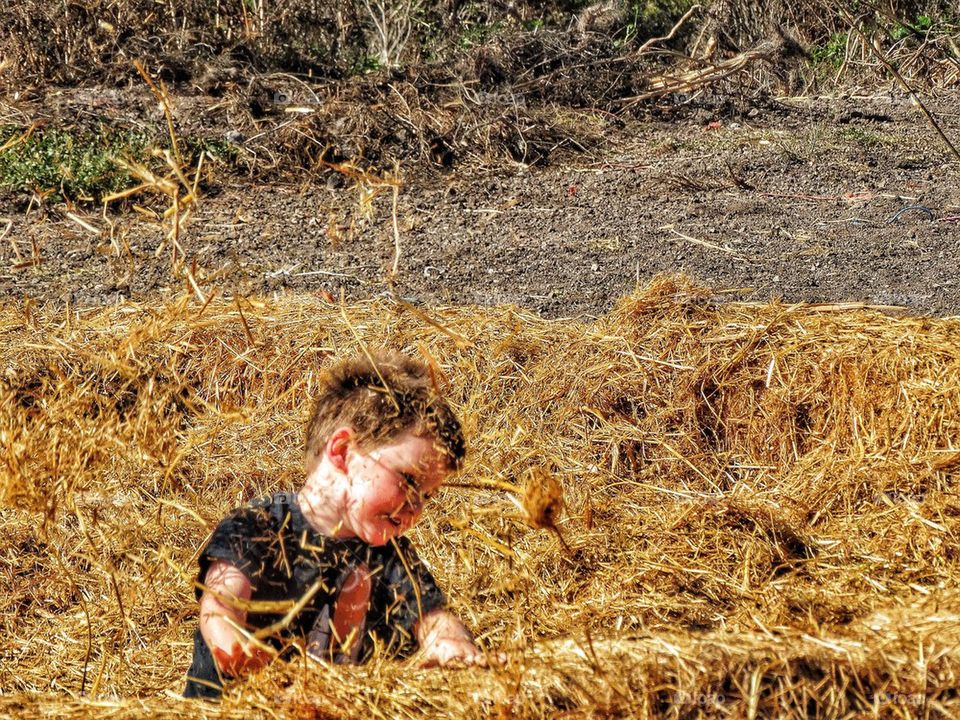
[0,90,960,316]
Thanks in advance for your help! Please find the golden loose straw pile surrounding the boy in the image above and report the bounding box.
[0,277,960,718]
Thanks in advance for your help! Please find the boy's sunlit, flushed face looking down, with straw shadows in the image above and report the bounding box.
[344,432,449,545]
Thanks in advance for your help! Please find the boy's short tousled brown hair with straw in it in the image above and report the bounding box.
[305,351,466,471]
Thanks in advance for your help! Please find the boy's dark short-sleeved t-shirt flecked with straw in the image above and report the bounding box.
[184,493,446,697]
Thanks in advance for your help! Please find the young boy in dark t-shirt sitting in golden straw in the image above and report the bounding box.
[184,353,483,698]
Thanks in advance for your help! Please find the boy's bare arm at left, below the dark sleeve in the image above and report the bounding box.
[200,560,270,677]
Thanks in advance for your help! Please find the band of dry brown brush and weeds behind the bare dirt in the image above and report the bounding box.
[0,0,960,178]
